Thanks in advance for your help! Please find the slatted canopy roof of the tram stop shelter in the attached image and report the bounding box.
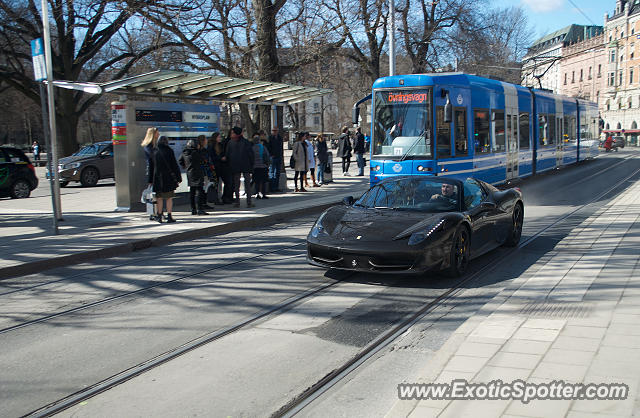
[68,70,333,105]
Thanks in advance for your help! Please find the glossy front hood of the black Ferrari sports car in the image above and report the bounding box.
[320,206,445,242]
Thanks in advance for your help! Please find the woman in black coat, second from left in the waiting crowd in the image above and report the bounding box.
[152,135,182,223]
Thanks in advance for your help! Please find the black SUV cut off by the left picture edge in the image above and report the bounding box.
[0,147,38,199]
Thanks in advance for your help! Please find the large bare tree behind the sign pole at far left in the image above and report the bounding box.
[0,0,177,154]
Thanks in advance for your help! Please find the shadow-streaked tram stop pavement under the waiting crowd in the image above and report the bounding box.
[0,168,369,279]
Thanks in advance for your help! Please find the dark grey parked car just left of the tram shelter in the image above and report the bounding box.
[47,141,115,187]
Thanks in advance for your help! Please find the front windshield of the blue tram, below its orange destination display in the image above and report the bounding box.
[371,89,433,160]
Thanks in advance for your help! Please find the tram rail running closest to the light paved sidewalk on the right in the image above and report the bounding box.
[271,164,640,418]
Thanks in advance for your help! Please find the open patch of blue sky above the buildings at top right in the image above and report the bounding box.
[490,0,616,39]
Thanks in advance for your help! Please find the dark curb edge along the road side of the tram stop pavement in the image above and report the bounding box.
[0,201,340,280]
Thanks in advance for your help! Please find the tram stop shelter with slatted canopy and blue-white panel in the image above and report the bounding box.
[54,70,332,211]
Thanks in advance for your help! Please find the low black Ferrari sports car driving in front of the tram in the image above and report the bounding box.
[307,176,524,276]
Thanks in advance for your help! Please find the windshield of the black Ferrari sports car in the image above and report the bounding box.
[354,178,459,212]
